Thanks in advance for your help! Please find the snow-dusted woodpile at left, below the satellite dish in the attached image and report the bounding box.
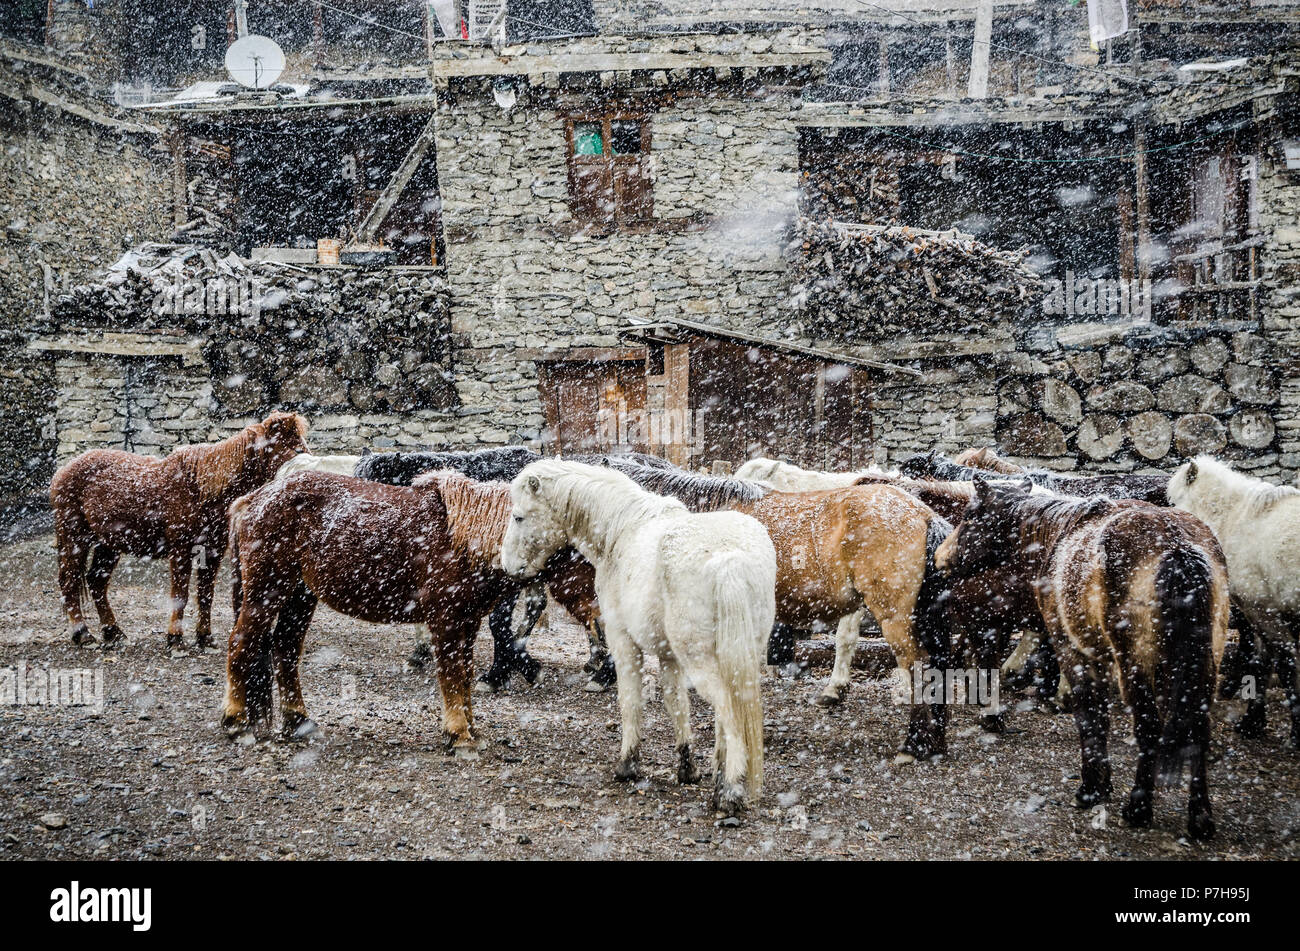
[52,244,455,416]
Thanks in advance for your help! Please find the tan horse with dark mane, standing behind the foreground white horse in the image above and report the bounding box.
[611,463,950,757]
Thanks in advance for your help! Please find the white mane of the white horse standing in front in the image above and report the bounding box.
[520,459,688,551]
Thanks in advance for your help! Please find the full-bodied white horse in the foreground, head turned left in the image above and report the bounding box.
[501,460,776,815]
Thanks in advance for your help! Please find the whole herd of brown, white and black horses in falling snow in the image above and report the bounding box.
[51,413,1300,838]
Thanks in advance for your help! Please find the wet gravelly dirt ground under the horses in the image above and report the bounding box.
[0,535,1300,859]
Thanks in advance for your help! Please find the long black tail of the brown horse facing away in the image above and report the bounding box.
[1156,546,1214,785]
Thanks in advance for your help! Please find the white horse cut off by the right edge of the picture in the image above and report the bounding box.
[1167,456,1300,748]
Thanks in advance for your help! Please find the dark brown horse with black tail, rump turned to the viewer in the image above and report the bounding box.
[935,481,1229,838]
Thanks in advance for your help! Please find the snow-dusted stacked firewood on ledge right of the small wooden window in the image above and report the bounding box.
[793,217,1043,338]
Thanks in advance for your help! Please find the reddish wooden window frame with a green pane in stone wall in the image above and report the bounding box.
[564,108,654,234]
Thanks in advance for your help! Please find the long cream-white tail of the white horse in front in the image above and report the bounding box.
[710,552,774,800]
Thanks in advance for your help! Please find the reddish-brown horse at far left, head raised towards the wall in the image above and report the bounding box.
[49,413,307,648]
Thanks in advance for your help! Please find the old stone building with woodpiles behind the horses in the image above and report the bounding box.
[0,0,1300,511]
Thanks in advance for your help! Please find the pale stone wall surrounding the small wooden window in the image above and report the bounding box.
[437,82,798,439]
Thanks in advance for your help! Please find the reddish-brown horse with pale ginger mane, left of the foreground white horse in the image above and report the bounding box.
[222,473,597,757]
